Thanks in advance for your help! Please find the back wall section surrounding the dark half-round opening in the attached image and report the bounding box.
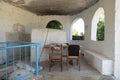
[38,15,72,42]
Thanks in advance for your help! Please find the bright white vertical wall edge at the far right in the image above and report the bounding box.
[114,0,120,80]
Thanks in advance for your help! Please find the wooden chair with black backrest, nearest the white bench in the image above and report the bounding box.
[67,44,81,70]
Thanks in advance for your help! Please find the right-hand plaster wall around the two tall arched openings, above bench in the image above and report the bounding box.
[73,0,115,60]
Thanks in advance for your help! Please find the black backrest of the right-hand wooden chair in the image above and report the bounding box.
[68,44,80,56]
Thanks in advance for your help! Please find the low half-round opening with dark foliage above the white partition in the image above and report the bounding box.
[46,20,63,30]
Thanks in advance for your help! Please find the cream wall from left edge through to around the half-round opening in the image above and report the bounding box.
[0,1,71,62]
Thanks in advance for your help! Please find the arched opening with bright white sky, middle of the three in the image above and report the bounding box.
[71,18,85,40]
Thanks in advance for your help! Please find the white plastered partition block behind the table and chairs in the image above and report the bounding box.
[31,29,67,62]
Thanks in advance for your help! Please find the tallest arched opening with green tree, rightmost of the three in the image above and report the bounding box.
[91,8,105,41]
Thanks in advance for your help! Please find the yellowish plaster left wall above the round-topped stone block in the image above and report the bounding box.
[0,1,38,63]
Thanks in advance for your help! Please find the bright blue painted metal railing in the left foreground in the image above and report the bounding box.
[0,42,42,80]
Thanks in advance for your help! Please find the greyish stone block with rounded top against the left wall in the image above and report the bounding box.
[6,23,31,42]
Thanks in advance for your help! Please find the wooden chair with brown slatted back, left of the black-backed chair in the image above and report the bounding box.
[49,44,63,71]
